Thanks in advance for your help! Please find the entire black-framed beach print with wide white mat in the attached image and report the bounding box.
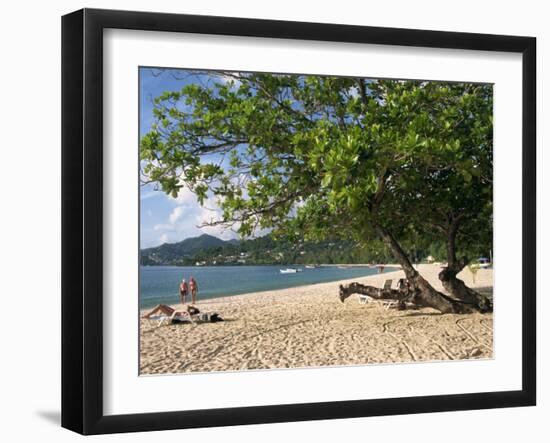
[62,9,536,434]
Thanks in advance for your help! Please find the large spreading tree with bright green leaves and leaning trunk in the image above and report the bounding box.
[140,72,492,312]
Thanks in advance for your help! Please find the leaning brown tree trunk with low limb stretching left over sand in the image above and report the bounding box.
[340,225,477,314]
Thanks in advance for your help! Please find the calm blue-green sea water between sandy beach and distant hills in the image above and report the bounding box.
[139,265,395,309]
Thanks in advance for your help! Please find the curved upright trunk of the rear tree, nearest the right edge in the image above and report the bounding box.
[439,217,493,312]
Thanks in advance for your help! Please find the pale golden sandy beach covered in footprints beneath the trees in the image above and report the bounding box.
[140,265,493,375]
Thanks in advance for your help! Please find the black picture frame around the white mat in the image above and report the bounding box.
[62,9,536,434]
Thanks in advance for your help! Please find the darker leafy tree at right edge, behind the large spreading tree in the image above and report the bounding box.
[368,85,493,310]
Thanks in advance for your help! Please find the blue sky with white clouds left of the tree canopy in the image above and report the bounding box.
[139,68,237,248]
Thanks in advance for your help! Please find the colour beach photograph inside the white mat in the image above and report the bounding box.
[137,67,494,376]
